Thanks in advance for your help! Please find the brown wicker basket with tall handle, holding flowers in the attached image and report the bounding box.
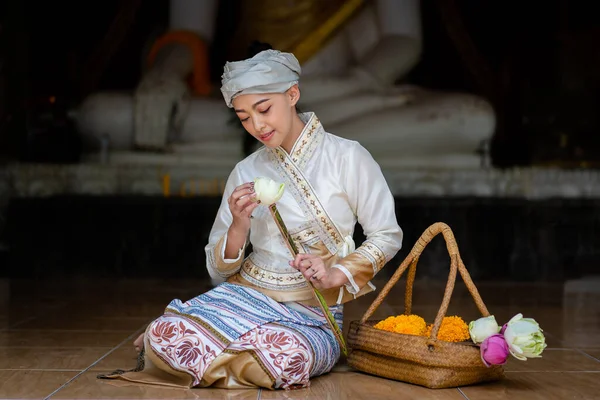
[348,223,504,389]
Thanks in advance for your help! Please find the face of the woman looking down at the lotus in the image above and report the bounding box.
[233,85,300,151]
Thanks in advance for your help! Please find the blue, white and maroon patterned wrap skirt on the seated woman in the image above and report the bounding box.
[103,283,343,390]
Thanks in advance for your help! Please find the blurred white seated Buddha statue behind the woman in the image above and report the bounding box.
[76,0,495,170]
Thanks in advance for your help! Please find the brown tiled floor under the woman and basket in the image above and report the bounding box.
[0,276,600,400]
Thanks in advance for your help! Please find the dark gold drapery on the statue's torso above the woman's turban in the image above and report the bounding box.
[232,0,366,63]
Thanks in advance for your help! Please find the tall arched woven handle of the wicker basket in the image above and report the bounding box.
[360,222,490,341]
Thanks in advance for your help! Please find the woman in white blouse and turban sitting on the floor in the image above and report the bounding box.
[103,50,402,389]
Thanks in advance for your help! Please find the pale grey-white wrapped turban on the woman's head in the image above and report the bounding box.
[221,50,301,108]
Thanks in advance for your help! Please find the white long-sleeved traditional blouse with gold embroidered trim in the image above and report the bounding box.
[206,113,403,305]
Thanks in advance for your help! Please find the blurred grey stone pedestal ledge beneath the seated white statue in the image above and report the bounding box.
[5,163,600,199]
